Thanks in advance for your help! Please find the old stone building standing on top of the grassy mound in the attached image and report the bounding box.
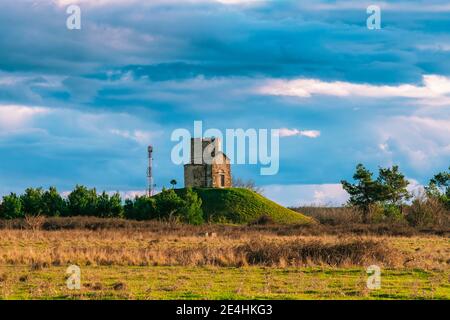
[184,138,232,188]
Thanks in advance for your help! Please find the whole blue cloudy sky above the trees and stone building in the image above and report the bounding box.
[0,0,450,205]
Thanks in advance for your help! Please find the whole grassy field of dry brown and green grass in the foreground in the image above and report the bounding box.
[0,218,450,299]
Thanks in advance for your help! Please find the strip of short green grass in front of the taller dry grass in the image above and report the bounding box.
[0,266,450,299]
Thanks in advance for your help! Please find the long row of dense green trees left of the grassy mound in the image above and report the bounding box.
[0,185,203,224]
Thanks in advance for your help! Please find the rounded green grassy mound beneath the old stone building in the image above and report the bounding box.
[177,188,314,224]
